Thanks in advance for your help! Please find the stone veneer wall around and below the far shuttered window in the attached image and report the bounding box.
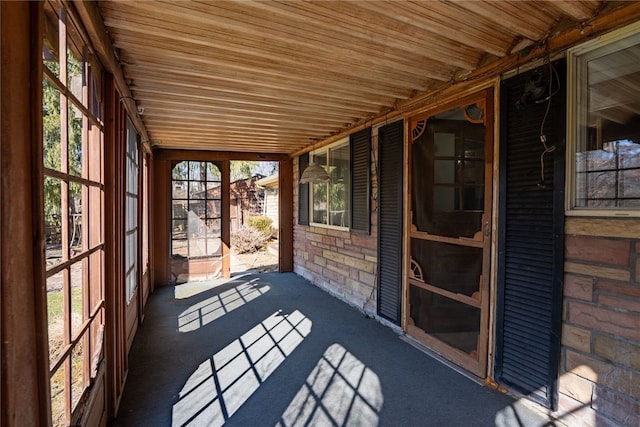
[293,129,378,315]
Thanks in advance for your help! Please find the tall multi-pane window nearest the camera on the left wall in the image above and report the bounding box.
[42,3,105,425]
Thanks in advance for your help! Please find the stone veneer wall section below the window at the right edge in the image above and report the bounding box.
[558,218,640,427]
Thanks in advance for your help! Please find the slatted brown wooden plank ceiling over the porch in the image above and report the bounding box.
[99,0,602,153]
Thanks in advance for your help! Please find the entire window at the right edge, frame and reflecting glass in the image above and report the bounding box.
[567,24,640,216]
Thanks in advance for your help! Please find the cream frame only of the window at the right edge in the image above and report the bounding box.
[565,22,640,217]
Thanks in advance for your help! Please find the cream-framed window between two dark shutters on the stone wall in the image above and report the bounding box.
[310,138,351,229]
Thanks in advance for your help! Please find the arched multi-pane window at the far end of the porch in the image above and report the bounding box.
[171,161,222,259]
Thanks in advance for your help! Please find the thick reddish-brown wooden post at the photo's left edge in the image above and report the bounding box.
[0,2,51,427]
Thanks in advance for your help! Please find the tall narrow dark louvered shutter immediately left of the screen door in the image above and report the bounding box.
[378,121,405,324]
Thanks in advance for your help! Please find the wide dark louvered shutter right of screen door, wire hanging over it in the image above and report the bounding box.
[496,61,566,409]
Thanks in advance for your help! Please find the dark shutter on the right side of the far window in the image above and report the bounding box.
[350,128,371,234]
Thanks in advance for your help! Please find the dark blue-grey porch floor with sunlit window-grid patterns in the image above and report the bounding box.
[113,273,554,427]
